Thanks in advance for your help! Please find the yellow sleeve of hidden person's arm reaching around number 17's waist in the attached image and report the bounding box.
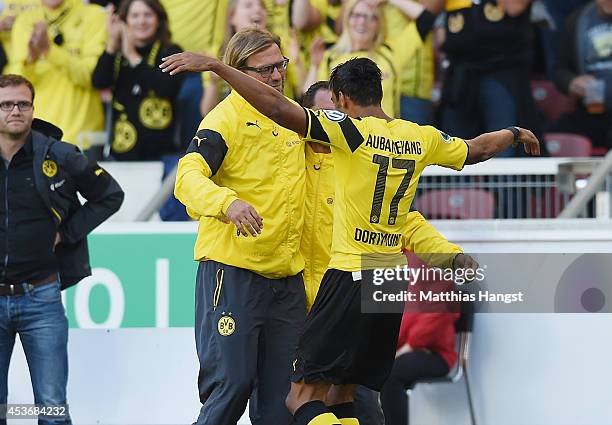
[402,211,463,267]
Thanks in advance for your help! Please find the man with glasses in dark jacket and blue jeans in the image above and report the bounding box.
[0,75,123,425]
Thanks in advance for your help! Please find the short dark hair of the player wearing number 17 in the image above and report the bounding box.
[329,58,382,106]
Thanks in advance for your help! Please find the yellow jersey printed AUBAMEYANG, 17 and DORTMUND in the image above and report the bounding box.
[304,110,468,271]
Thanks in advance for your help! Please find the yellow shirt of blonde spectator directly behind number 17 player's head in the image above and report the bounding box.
[317,23,423,118]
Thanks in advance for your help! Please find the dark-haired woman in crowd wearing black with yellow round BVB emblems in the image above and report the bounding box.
[93,0,182,161]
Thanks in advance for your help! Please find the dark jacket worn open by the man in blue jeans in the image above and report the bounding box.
[32,120,124,289]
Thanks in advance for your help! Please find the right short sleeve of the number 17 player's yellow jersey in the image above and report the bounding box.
[419,125,468,170]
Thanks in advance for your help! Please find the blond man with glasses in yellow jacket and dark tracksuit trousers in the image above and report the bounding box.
[175,30,306,425]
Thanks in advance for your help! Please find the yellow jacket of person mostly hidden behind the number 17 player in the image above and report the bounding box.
[300,143,463,311]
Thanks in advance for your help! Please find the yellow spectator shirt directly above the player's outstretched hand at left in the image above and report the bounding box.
[161,0,228,53]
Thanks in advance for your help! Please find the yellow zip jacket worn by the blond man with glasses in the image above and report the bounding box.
[174,92,305,279]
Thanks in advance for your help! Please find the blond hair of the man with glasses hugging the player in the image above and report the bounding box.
[223,28,281,69]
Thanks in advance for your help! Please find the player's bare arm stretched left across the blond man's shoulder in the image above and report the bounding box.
[159,52,308,136]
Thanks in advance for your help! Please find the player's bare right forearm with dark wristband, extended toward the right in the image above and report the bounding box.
[465,127,540,165]
